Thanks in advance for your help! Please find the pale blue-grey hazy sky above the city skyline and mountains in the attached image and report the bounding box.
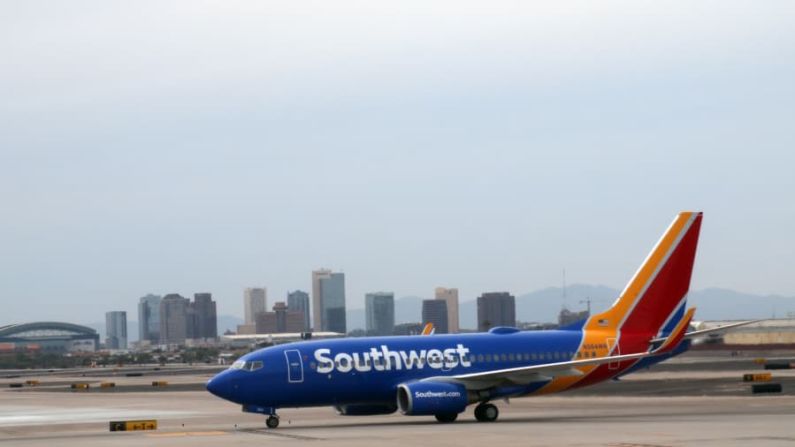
[0,0,795,324]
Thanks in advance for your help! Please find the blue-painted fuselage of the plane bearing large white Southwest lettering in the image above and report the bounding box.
[207,329,684,408]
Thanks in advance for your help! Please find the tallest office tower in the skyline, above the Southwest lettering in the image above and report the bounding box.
[312,269,347,334]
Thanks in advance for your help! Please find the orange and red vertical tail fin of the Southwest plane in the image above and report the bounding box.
[586,212,702,344]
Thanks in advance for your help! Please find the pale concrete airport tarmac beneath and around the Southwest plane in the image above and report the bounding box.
[0,358,795,447]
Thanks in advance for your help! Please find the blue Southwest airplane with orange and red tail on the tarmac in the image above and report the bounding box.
[207,212,750,428]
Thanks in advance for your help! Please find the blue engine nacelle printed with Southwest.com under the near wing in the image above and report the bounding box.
[397,381,470,416]
